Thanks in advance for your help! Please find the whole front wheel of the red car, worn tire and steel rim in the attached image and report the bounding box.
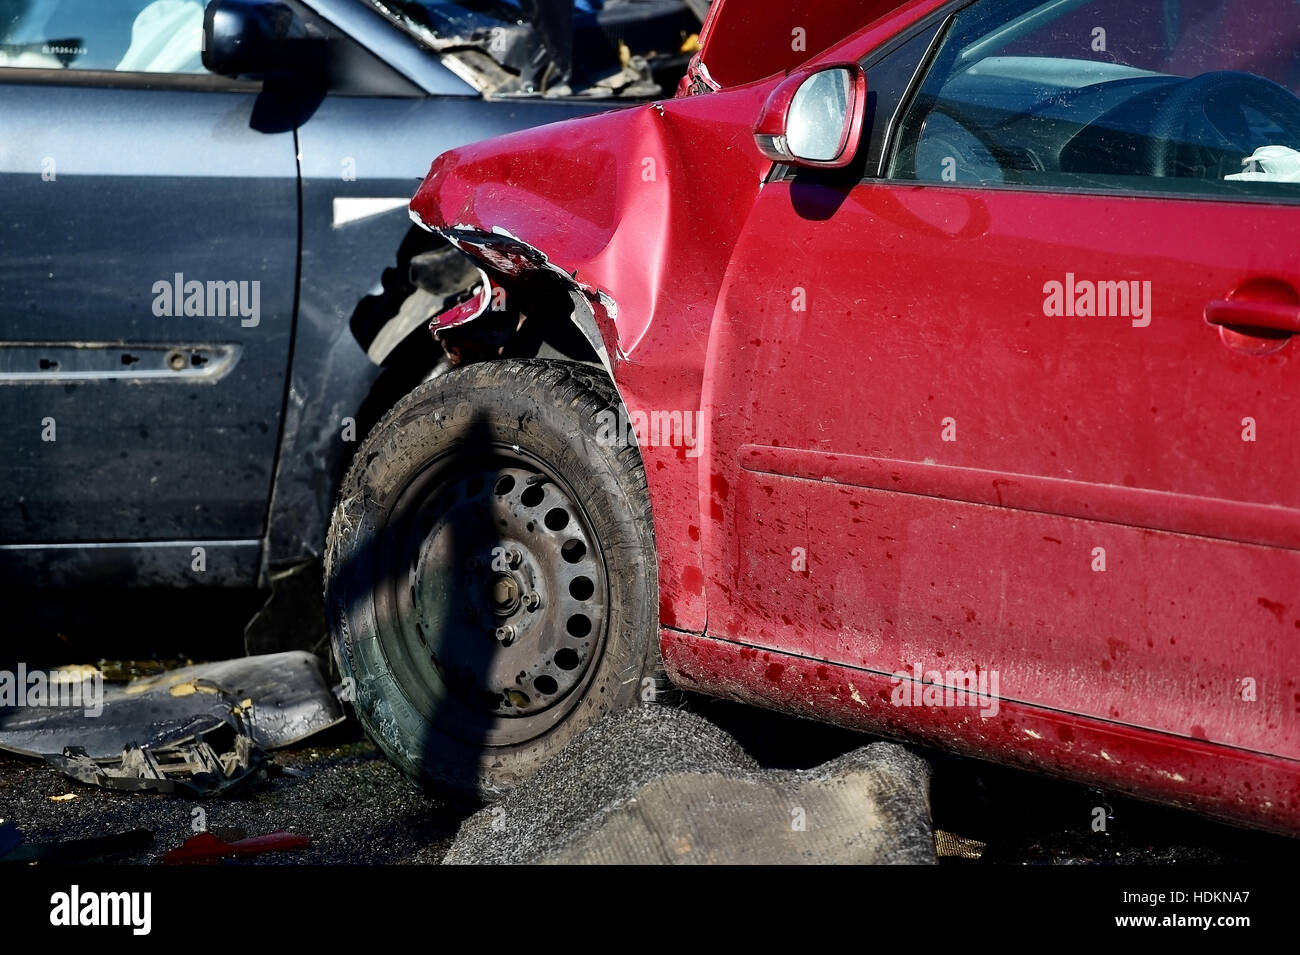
[325,360,659,800]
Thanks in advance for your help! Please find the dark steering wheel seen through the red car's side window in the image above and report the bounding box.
[1148,70,1300,177]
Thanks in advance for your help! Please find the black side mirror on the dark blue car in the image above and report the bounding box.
[203,0,309,79]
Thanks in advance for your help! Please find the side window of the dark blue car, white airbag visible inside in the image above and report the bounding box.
[0,0,204,73]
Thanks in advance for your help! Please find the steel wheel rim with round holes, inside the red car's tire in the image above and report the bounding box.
[376,447,610,745]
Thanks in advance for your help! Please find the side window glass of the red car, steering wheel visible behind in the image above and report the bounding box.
[887,0,1300,199]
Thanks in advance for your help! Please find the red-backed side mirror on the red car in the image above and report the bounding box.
[754,64,867,169]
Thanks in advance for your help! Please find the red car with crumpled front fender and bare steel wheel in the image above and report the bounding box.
[326,0,1300,832]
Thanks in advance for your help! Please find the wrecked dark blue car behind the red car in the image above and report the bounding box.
[0,0,699,644]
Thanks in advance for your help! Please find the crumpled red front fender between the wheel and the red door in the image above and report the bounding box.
[411,78,771,639]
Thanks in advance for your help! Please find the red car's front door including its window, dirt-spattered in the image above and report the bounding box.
[702,0,1300,758]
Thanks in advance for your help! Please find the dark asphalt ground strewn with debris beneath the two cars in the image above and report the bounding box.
[0,699,1300,865]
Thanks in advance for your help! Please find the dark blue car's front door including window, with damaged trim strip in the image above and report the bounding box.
[0,0,298,560]
